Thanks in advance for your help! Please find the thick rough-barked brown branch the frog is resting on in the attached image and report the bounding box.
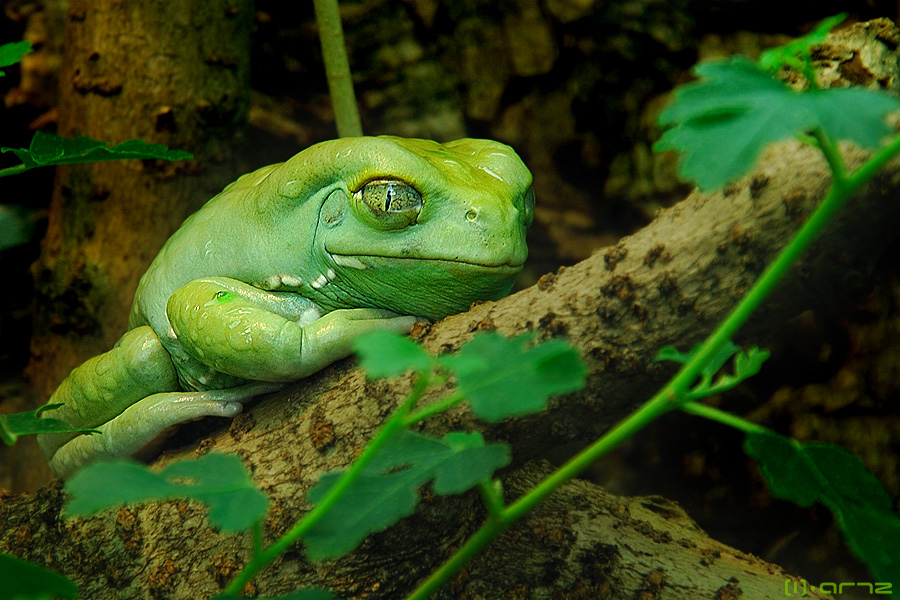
[0,22,900,599]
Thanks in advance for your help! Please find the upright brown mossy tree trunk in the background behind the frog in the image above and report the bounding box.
[8,0,253,489]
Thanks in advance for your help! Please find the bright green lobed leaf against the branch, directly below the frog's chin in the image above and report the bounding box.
[440,333,587,422]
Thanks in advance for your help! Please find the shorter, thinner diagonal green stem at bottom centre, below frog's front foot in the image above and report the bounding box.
[224,372,431,596]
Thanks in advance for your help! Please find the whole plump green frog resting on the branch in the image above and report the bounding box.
[39,137,534,477]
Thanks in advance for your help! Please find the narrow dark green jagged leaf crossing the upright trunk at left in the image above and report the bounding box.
[0,131,193,169]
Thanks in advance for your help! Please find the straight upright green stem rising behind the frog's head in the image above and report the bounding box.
[315,0,362,137]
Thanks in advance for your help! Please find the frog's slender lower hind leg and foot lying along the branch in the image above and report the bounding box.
[49,383,282,478]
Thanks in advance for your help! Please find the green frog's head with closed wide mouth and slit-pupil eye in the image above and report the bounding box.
[264,137,534,319]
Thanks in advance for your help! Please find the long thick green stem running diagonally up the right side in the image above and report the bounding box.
[407,129,900,600]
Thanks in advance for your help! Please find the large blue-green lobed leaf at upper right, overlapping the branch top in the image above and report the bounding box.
[655,57,900,189]
